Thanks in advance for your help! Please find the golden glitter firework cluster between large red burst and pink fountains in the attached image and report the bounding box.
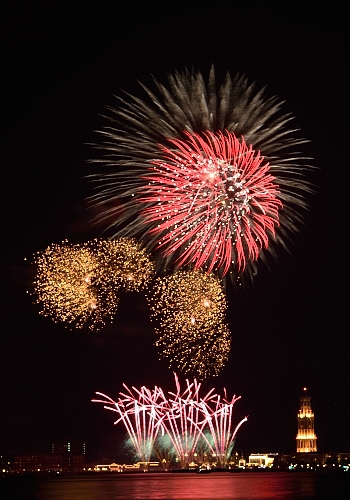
[148,270,231,379]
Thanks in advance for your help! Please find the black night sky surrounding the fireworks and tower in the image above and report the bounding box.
[0,2,350,457]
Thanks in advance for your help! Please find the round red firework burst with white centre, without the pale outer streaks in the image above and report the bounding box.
[141,131,282,275]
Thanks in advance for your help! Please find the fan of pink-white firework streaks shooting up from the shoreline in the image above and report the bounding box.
[93,374,247,468]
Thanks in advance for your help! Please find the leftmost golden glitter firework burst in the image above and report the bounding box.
[34,241,119,330]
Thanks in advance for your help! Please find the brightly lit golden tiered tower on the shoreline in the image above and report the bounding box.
[297,387,317,453]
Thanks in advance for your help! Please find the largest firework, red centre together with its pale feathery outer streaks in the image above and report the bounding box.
[92,69,311,279]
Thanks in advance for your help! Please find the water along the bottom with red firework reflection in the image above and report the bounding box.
[0,473,350,500]
